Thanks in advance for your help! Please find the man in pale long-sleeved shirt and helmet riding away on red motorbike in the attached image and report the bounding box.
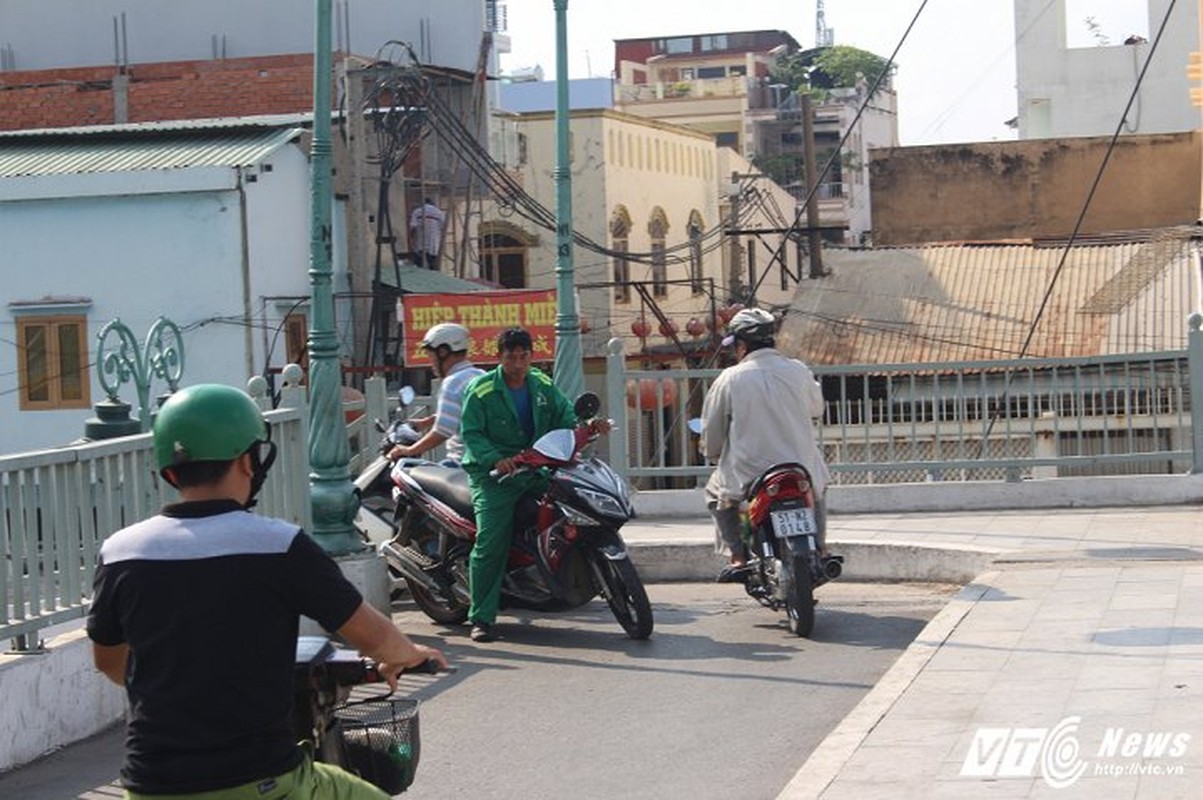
[701,308,828,581]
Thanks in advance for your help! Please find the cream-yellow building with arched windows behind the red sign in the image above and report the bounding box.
[478,109,799,363]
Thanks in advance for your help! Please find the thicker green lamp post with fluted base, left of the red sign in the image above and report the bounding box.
[309,0,363,556]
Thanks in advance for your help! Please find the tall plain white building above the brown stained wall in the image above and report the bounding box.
[1015,0,1199,138]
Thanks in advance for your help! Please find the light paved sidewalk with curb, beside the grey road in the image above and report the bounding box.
[628,506,1203,800]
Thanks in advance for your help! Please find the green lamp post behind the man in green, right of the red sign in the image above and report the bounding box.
[553,0,585,398]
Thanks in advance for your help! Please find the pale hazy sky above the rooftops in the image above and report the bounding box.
[502,0,1151,144]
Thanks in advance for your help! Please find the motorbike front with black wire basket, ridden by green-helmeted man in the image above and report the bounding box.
[292,636,439,795]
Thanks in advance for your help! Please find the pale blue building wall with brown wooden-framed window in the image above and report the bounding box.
[0,120,345,452]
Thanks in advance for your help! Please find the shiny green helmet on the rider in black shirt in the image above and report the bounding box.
[154,384,271,472]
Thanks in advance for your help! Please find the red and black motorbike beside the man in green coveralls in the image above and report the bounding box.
[380,392,653,639]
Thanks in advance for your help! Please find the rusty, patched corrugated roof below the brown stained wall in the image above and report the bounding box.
[781,229,1199,365]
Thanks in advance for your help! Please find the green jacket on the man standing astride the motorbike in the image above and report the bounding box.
[460,366,576,479]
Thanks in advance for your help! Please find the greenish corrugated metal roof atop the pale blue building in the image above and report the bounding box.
[0,126,302,178]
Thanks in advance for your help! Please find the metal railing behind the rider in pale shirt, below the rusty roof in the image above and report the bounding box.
[606,329,1203,488]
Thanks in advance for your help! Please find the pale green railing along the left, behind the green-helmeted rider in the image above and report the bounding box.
[0,379,429,651]
